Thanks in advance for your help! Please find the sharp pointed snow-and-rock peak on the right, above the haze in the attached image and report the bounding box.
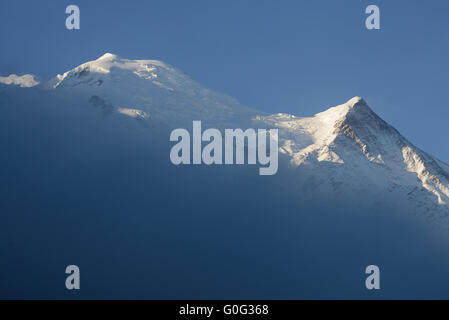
[256,97,449,215]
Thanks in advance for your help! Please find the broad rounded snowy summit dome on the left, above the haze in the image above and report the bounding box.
[50,53,256,126]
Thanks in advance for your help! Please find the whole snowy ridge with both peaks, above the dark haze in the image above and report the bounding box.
[0,53,449,222]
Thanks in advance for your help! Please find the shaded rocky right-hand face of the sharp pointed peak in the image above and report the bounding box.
[334,100,449,204]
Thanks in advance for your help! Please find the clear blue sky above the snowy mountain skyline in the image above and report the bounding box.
[0,0,449,162]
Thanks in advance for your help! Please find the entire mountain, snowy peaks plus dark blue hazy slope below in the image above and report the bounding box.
[0,53,449,298]
